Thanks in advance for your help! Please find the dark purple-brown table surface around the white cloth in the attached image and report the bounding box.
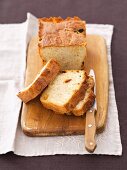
[0,0,127,170]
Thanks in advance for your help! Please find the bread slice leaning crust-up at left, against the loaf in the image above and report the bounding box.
[17,59,60,103]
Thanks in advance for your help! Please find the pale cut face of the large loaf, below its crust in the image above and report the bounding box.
[40,45,86,70]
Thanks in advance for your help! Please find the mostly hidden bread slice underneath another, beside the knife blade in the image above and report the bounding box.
[72,77,95,116]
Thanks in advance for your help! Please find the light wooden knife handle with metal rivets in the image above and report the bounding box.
[85,109,96,152]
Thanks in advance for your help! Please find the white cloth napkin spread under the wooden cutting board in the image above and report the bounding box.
[0,13,122,156]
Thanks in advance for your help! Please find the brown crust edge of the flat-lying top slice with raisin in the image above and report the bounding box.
[40,72,88,114]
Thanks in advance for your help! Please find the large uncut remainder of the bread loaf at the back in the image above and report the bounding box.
[38,17,86,70]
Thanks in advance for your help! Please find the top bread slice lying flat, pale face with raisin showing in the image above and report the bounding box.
[40,70,88,114]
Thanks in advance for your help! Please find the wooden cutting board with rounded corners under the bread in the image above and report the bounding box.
[21,35,108,136]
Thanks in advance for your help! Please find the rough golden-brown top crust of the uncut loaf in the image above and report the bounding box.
[38,17,86,48]
